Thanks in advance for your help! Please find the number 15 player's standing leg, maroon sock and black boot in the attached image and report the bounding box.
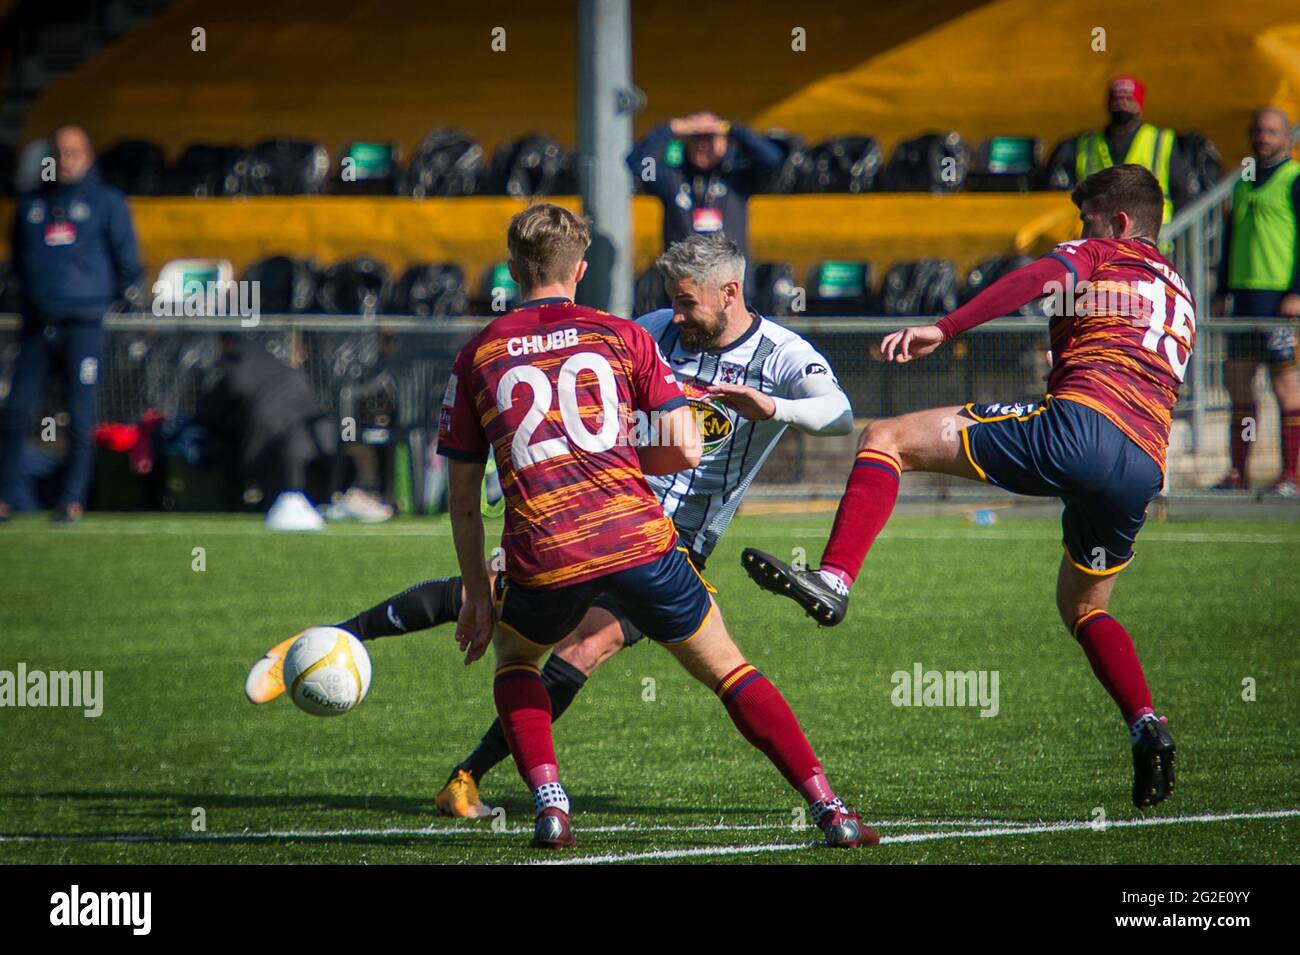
[1057,557,1178,808]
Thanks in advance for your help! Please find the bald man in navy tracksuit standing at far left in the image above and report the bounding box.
[0,126,140,524]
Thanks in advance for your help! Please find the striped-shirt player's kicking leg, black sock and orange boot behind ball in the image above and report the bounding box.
[244,577,464,703]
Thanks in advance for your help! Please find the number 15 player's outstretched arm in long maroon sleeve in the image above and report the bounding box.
[880,252,1091,363]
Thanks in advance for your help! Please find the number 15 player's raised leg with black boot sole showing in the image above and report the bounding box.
[741,407,979,626]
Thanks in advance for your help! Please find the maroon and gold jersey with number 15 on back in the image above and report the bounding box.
[1048,239,1196,470]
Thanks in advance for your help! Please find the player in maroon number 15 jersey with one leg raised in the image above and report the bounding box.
[741,164,1196,807]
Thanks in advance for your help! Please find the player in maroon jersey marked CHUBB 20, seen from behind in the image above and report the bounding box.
[438,204,879,848]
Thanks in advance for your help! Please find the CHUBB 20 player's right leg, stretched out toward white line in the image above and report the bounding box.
[664,605,880,848]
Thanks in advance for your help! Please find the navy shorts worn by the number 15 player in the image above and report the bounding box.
[962,396,1165,576]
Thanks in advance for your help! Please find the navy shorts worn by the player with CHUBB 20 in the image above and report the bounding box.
[497,544,712,647]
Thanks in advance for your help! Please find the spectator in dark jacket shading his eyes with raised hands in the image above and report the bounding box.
[628,112,785,257]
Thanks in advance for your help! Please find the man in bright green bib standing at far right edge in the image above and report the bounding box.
[1214,107,1300,498]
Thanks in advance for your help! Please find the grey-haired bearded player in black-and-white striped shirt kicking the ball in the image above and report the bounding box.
[247,235,853,817]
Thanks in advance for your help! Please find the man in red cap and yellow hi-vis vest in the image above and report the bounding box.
[1048,77,1190,222]
